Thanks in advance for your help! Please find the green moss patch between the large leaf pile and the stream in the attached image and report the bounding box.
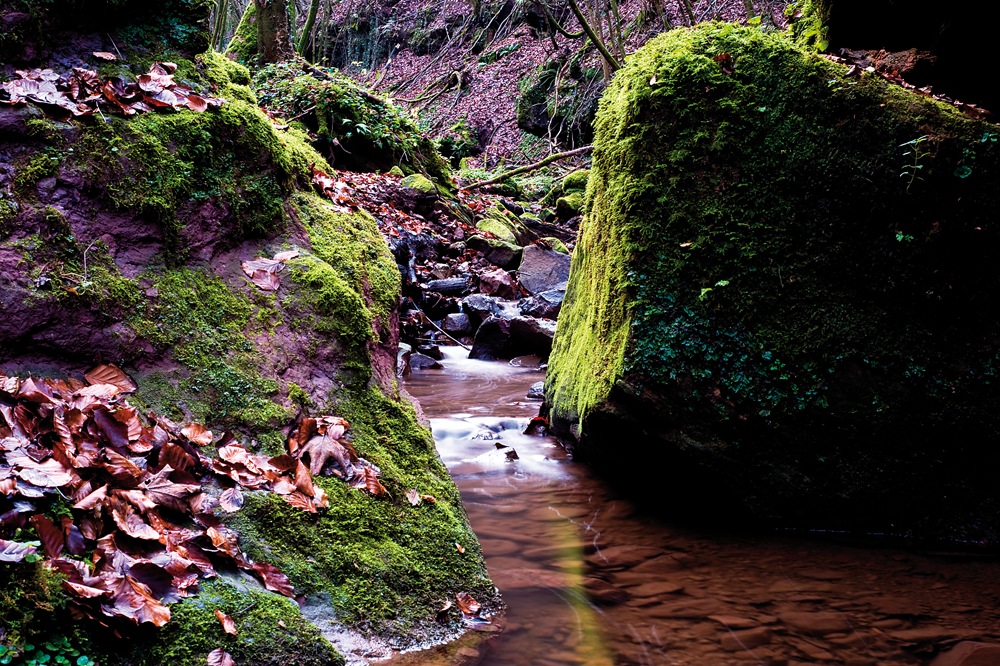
[231,389,493,644]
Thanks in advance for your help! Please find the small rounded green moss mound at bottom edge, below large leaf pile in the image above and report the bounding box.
[135,579,344,666]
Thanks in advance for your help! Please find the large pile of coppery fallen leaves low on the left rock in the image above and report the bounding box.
[0,365,385,626]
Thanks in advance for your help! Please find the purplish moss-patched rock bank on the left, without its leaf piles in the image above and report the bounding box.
[0,0,494,664]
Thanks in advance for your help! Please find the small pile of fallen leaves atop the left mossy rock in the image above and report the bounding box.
[0,62,223,120]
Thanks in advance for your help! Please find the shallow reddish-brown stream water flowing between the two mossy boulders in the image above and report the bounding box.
[404,348,1000,666]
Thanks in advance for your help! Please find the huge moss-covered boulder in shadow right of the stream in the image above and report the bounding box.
[546,24,1000,542]
